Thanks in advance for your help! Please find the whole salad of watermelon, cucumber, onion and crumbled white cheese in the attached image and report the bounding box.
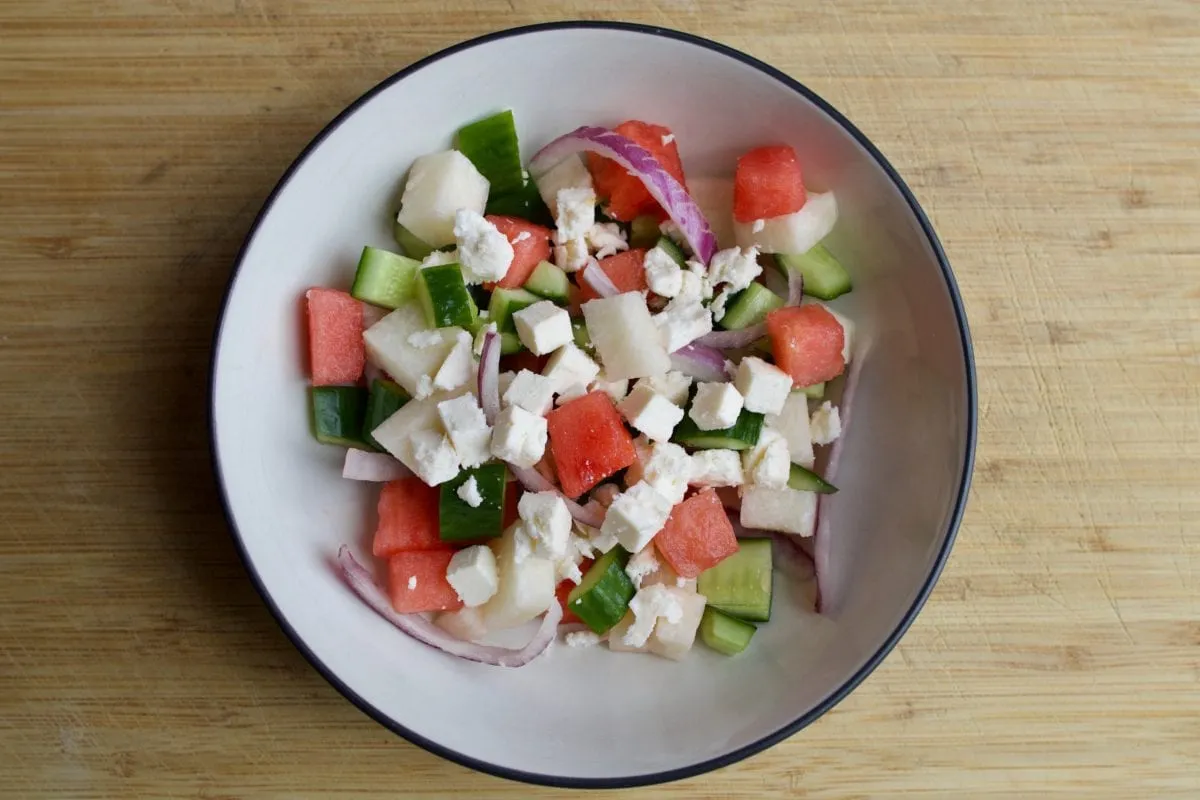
[306,112,853,667]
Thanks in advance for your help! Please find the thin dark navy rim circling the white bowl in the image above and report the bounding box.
[208,19,978,789]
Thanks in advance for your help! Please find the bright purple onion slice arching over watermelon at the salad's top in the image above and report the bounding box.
[529,126,716,264]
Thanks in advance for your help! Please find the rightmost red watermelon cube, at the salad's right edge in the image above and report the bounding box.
[767,303,846,386]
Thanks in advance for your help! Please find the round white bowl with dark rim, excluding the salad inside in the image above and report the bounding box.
[211,23,976,787]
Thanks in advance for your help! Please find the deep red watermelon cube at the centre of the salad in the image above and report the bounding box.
[546,392,636,498]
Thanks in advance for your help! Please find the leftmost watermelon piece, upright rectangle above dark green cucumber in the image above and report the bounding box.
[305,289,366,386]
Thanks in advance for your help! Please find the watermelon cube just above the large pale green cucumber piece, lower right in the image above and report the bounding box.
[654,488,738,578]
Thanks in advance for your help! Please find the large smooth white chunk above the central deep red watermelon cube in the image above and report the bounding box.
[583,291,671,380]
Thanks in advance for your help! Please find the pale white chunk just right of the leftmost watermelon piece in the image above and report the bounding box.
[362,301,466,397]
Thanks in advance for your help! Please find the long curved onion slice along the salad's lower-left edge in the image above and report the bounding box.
[337,545,563,667]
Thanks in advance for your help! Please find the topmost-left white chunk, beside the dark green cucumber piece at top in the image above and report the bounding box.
[396,150,488,247]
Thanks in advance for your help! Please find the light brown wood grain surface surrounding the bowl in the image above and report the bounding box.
[0,0,1200,799]
